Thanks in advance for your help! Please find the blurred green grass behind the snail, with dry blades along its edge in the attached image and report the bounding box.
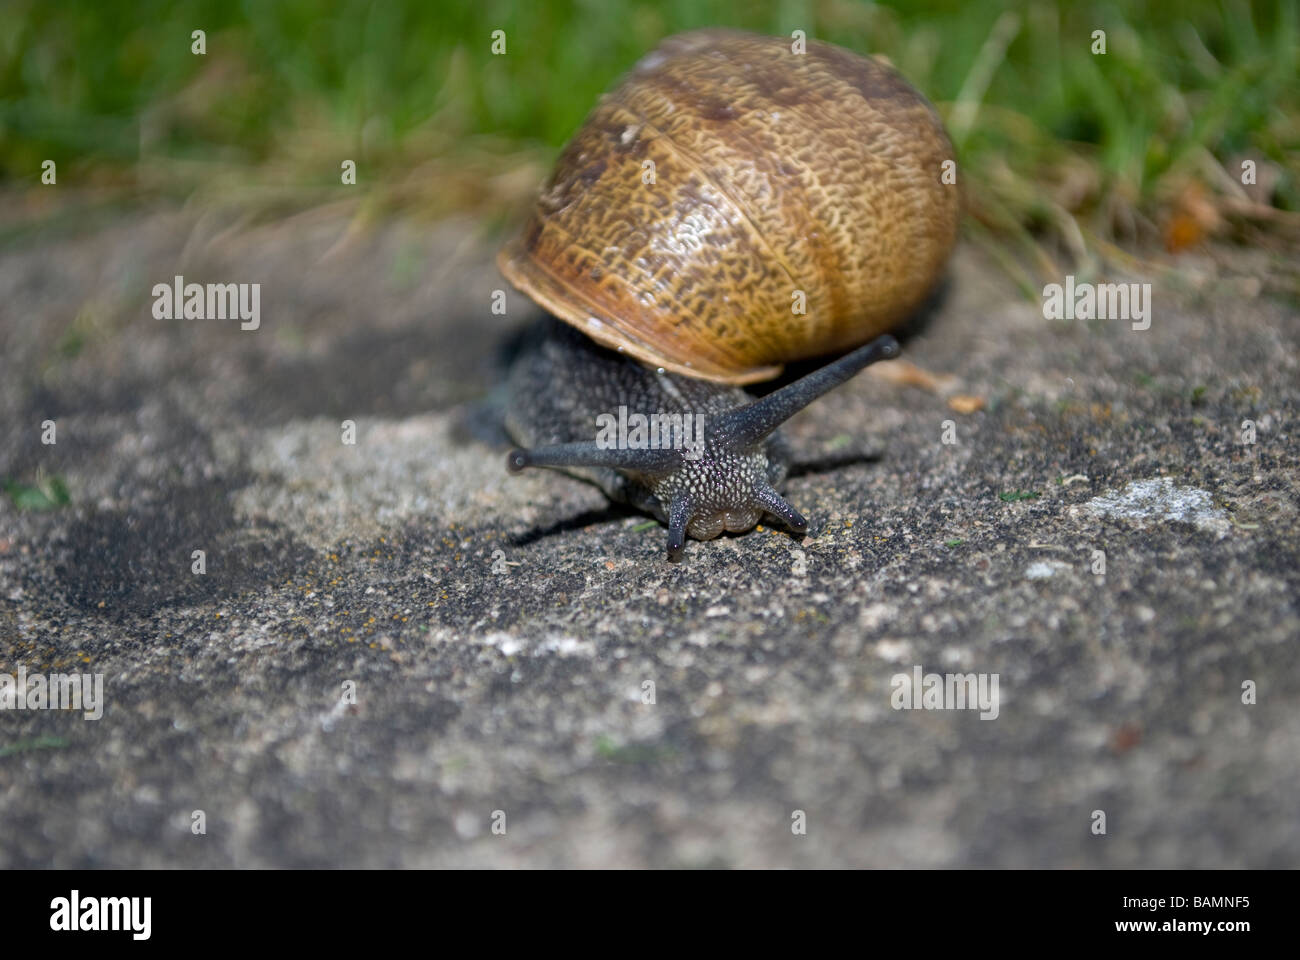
[0,0,1300,282]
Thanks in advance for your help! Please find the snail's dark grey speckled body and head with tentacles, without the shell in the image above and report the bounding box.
[506,319,898,561]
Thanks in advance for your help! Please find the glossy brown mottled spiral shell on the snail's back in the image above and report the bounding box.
[498,30,959,384]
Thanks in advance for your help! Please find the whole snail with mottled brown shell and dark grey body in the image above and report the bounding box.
[497,30,958,561]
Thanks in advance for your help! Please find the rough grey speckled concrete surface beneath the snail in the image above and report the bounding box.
[0,197,1300,868]
